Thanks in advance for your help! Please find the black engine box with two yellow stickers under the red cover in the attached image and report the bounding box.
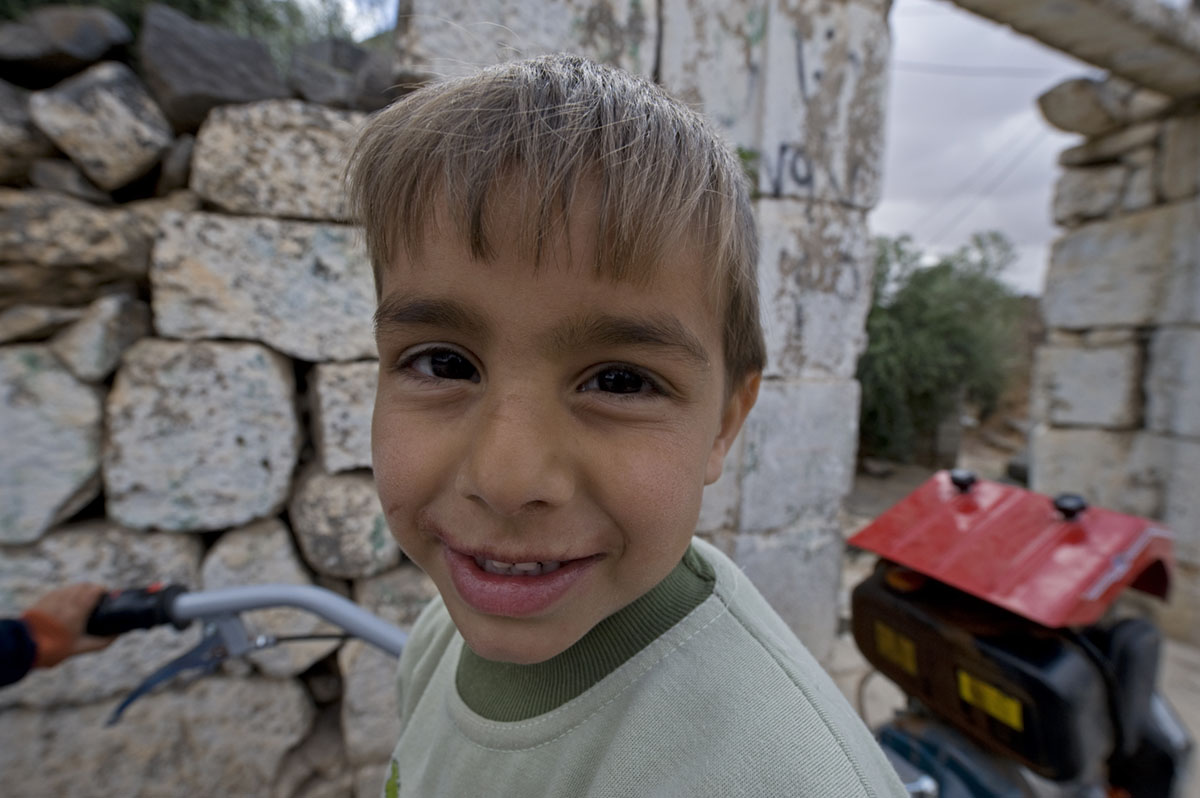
[852,562,1116,780]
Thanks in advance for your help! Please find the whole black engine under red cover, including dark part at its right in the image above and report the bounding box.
[852,562,1192,798]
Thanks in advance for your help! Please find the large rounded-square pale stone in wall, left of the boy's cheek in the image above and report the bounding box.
[103,338,300,530]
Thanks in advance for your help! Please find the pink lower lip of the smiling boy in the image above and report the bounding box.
[442,545,600,618]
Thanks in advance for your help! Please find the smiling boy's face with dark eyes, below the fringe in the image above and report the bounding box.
[372,189,758,664]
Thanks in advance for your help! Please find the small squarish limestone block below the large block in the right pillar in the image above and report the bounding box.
[1031,343,1141,430]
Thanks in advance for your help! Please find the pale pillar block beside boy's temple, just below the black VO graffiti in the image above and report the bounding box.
[758,200,875,378]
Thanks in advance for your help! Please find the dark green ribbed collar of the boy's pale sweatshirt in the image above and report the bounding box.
[456,546,716,721]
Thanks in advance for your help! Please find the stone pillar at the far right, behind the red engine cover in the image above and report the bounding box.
[1032,78,1200,642]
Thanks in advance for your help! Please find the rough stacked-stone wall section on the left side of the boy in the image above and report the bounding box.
[0,6,433,798]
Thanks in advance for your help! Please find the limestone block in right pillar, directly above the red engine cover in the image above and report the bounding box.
[1030,425,1171,517]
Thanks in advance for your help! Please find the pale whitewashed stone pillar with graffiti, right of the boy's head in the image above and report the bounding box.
[659,0,890,658]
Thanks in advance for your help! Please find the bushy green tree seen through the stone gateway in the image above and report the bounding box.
[858,233,1021,460]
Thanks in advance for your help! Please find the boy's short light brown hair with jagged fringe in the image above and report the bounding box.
[347,55,766,390]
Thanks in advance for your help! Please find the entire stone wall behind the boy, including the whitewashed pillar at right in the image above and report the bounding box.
[0,0,888,798]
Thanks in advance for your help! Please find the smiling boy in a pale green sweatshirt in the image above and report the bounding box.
[349,56,904,798]
